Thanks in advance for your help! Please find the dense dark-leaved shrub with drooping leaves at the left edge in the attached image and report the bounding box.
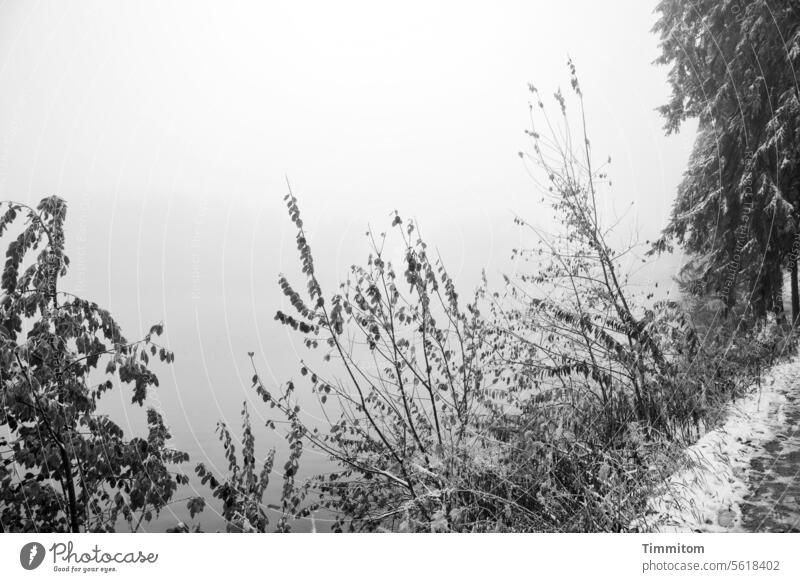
[0,197,188,532]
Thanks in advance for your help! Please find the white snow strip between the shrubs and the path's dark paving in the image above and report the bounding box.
[634,357,800,532]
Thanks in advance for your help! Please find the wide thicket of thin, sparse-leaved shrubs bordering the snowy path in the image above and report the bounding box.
[214,63,792,531]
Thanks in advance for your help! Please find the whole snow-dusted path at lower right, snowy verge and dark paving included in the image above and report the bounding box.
[636,357,800,532]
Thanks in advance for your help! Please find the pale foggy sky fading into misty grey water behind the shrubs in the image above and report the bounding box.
[0,0,694,528]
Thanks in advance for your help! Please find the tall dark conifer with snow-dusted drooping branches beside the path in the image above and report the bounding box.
[655,0,800,318]
